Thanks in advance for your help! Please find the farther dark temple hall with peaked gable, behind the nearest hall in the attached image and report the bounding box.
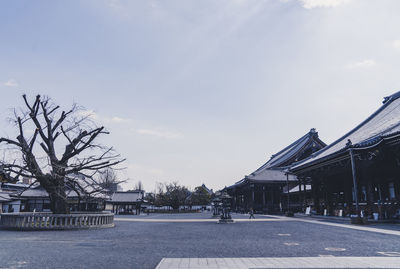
[226,129,326,213]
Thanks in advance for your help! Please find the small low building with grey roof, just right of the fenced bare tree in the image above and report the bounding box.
[106,190,144,215]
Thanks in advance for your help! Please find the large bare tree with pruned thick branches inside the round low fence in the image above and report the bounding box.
[0,95,124,214]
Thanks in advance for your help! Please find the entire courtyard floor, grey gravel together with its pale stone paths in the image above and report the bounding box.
[0,213,400,269]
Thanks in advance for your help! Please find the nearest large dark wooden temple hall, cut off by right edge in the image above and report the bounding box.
[290,92,400,218]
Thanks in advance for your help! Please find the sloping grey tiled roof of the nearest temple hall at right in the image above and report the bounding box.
[291,92,400,171]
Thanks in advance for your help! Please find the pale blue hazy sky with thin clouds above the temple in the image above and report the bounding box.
[0,0,400,192]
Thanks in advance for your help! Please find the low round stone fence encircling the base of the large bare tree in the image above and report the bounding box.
[0,212,114,230]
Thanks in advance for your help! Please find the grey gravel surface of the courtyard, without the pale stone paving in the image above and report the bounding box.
[0,213,400,269]
